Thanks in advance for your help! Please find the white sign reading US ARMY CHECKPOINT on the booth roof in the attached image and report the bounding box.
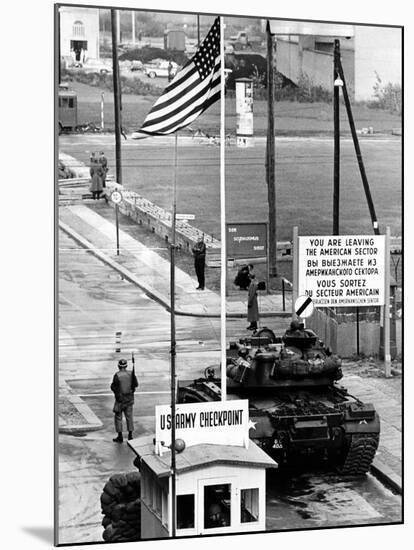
[155,399,249,453]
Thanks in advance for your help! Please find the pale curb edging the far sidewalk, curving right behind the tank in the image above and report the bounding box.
[59,220,292,319]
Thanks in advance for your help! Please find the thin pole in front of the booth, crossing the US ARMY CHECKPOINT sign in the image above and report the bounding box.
[170,132,178,537]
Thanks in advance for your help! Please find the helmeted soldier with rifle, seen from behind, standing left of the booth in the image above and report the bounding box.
[111,359,138,443]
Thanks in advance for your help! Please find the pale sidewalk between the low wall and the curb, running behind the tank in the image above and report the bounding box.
[59,204,292,318]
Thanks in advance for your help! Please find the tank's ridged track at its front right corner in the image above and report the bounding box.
[338,433,379,475]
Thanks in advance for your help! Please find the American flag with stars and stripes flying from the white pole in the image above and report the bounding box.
[138,17,220,136]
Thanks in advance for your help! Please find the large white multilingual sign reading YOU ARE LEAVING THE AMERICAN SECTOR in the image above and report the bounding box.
[298,235,385,307]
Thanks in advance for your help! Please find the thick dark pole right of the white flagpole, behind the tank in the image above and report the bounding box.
[266,21,277,277]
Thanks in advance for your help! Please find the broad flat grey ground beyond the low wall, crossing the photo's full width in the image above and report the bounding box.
[59,134,402,240]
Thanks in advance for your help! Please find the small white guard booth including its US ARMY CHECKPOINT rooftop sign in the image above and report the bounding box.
[128,400,277,539]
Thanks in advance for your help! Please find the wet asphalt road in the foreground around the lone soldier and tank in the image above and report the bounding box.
[58,232,401,544]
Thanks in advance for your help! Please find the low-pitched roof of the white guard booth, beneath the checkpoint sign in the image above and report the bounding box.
[128,436,277,477]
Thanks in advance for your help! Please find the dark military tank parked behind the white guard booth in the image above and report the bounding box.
[177,321,380,475]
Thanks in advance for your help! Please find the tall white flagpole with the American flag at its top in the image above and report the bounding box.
[220,16,227,401]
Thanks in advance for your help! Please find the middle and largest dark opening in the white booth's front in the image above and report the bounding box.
[204,483,231,529]
